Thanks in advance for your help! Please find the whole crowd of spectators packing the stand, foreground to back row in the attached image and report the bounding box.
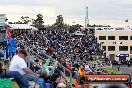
[0,30,107,88]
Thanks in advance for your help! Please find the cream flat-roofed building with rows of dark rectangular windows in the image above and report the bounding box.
[84,26,132,61]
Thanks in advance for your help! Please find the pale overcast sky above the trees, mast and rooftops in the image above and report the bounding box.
[0,0,132,26]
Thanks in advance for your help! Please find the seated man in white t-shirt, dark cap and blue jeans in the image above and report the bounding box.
[9,50,39,87]
